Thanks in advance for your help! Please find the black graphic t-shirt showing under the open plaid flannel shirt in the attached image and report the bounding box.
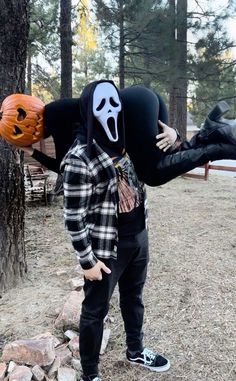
[113,154,145,236]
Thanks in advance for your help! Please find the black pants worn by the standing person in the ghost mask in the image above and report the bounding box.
[80,230,148,375]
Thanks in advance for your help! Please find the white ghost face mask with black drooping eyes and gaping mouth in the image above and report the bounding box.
[93,82,121,142]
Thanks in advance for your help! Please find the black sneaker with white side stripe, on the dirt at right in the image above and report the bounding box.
[127,348,170,372]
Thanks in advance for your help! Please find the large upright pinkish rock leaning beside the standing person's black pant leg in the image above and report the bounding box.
[55,290,84,329]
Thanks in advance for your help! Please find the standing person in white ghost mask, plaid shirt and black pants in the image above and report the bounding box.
[61,80,170,381]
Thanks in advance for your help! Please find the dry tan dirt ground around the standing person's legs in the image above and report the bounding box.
[0,175,236,381]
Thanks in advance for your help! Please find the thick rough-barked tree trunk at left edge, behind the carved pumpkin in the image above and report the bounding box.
[0,0,29,293]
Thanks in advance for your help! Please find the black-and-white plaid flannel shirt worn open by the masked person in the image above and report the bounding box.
[61,141,146,270]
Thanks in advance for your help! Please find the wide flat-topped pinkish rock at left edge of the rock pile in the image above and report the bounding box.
[2,337,55,366]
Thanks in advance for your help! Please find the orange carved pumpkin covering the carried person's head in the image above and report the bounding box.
[0,94,44,147]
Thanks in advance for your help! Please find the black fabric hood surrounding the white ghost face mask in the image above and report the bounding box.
[78,80,125,156]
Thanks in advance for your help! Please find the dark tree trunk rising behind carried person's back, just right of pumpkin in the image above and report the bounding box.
[60,0,72,98]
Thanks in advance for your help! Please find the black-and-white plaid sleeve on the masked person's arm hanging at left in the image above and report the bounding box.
[63,159,98,270]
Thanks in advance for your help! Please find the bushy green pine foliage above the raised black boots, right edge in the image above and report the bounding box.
[190,32,236,127]
